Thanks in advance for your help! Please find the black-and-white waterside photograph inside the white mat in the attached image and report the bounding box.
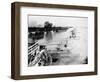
[27,14,88,67]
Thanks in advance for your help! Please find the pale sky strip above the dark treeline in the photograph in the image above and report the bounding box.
[28,15,88,27]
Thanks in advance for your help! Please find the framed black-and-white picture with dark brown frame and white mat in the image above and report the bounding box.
[11,2,98,80]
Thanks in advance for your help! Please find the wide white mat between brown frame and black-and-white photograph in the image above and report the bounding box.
[20,7,95,75]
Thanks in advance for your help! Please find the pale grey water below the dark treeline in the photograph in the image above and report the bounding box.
[38,28,88,65]
